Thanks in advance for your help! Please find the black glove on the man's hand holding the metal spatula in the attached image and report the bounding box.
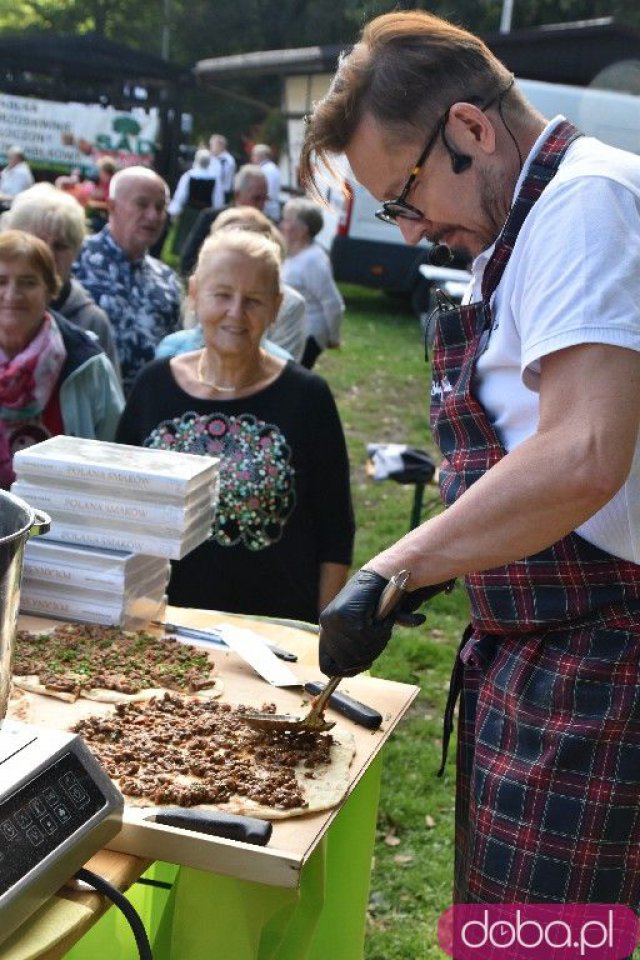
[320,570,453,677]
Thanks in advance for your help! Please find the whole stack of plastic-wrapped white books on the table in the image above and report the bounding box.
[11,436,218,629]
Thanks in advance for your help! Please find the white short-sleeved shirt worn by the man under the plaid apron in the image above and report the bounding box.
[466,117,640,563]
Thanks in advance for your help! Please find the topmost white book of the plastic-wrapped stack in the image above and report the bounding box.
[13,435,219,497]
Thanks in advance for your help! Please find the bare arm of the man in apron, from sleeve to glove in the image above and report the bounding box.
[366,344,640,588]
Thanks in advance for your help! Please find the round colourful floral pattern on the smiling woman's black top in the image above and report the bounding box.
[144,412,296,550]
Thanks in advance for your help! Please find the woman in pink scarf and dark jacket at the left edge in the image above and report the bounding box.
[0,230,123,489]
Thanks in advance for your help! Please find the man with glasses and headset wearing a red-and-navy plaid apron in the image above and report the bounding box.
[301,11,640,910]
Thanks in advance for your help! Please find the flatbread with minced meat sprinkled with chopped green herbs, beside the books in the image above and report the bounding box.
[13,623,222,703]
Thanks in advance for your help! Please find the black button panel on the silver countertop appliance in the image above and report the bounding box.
[0,752,107,898]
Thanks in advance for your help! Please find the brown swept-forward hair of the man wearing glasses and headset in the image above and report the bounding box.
[300,10,511,187]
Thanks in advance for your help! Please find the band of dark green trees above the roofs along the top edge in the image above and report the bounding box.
[0,0,640,65]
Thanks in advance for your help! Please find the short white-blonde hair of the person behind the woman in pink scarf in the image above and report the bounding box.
[0,183,87,250]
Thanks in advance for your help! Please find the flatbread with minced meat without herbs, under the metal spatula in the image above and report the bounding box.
[73,693,355,820]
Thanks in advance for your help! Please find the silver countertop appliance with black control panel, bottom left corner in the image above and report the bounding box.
[0,720,124,942]
